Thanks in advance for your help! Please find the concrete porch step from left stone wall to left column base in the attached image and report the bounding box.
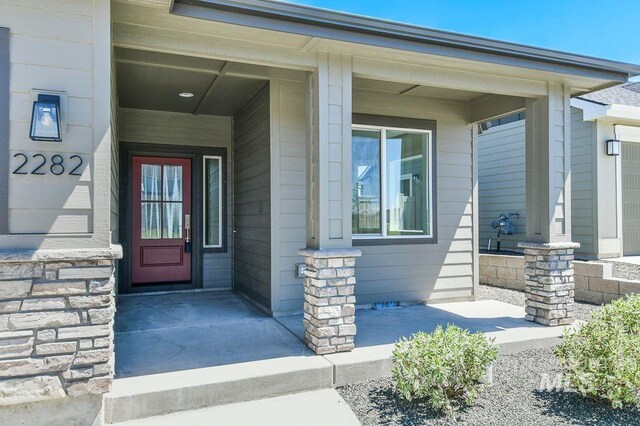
[104,356,333,424]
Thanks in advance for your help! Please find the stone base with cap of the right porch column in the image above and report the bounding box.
[518,242,580,326]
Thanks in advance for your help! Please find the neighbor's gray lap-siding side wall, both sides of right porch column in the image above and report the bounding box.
[478,108,603,258]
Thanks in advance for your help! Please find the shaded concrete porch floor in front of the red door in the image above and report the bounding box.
[115,291,313,378]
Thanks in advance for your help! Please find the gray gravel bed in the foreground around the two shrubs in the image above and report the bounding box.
[338,348,640,426]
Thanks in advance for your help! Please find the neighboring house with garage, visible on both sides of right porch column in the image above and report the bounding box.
[478,83,640,259]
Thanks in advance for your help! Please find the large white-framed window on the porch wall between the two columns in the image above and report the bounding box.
[352,125,433,239]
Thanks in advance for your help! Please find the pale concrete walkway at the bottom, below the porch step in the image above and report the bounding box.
[115,389,360,426]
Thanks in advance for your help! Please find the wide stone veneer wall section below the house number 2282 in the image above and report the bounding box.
[0,249,121,406]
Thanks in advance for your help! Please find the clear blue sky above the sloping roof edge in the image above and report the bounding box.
[287,0,640,64]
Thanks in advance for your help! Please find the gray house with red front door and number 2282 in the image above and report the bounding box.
[0,0,640,423]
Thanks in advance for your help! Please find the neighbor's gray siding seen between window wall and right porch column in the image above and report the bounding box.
[478,120,527,250]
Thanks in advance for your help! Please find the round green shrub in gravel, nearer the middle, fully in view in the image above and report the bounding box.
[393,325,498,414]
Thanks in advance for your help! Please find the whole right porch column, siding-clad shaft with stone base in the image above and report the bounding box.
[519,83,580,325]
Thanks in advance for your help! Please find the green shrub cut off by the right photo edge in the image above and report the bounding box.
[556,295,640,408]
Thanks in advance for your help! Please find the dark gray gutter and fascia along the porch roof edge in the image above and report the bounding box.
[171,0,640,82]
